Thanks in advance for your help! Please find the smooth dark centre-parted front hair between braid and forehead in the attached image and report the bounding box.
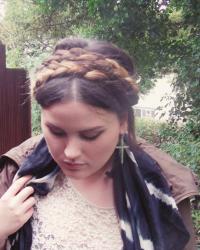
[35,76,129,119]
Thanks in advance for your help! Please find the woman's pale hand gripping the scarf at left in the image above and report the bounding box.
[0,176,36,241]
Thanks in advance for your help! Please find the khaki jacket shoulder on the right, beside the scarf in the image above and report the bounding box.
[138,138,198,204]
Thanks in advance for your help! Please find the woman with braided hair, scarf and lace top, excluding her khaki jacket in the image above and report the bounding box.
[0,39,189,250]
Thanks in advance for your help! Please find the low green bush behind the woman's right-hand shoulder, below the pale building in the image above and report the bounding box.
[136,119,200,177]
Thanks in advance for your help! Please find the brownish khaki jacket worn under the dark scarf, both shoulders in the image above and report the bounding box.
[0,135,198,250]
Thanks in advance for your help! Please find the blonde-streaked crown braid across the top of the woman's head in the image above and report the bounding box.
[33,48,138,99]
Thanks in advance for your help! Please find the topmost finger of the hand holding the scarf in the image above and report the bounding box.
[1,175,32,199]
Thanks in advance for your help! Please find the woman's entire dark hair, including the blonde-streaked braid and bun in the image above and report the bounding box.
[34,39,138,143]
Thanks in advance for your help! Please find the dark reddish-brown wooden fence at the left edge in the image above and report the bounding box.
[0,43,31,154]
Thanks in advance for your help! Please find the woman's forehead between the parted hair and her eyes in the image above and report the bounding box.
[42,101,119,129]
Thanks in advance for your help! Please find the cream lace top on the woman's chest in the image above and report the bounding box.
[31,175,122,250]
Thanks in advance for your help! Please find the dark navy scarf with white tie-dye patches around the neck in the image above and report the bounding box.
[9,138,189,250]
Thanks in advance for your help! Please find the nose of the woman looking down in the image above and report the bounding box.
[64,138,81,161]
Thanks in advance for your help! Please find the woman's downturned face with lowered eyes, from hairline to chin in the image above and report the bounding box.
[41,101,127,179]
